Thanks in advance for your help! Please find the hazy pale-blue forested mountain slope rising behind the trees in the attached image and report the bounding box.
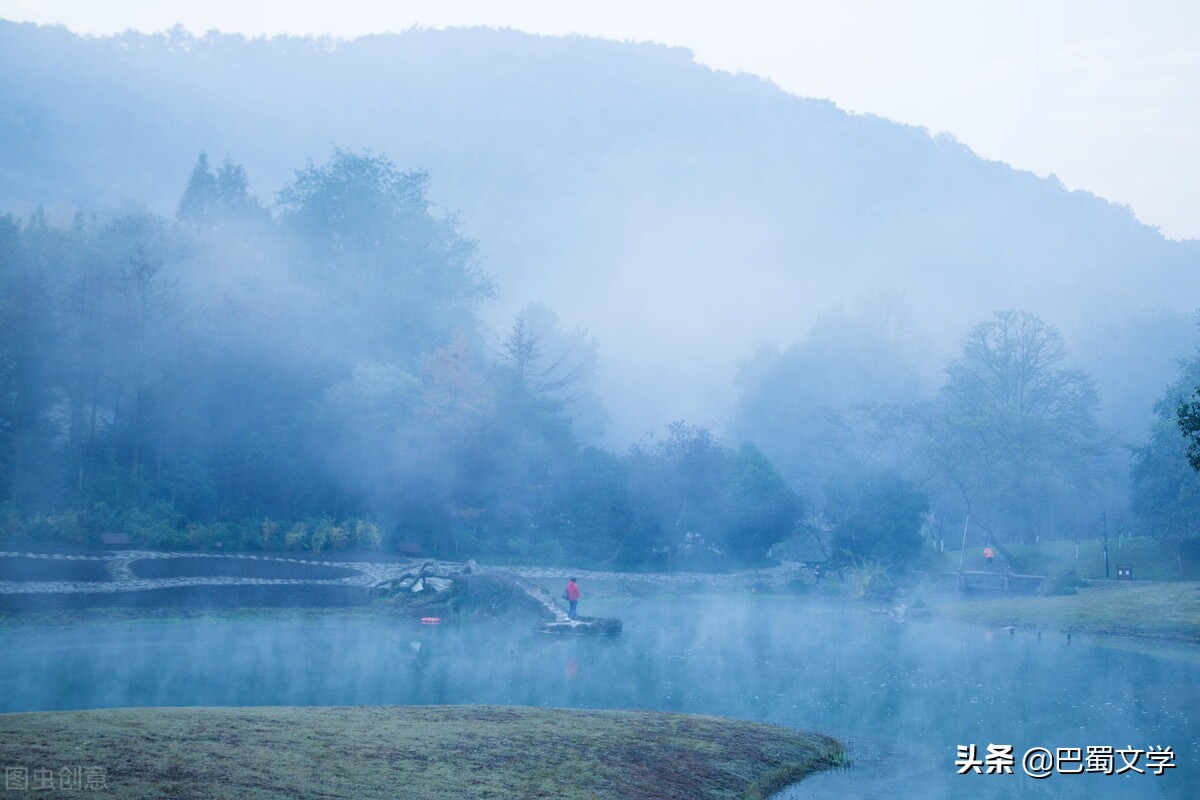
[0,22,1200,444]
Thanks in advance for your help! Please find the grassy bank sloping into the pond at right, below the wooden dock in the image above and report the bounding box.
[934,581,1200,643]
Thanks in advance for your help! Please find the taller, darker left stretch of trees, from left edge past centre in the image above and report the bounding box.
[0,150,802,566]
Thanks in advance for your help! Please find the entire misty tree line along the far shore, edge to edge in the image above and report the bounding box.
[0,150,1200,569]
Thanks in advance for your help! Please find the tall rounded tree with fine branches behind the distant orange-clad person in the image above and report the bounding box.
[929,311,1105,542]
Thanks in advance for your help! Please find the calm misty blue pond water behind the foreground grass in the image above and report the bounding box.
[0,597,1200,799]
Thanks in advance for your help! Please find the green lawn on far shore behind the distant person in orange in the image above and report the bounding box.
[929,536,1200,581]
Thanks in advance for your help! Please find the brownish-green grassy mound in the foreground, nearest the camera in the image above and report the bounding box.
[0,706,844,800]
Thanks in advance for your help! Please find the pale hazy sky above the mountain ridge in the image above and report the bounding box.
[7,0,1200,239]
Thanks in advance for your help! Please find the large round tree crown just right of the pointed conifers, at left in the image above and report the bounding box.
[277,149,492,367]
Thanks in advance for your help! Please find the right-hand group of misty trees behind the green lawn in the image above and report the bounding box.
[733,311,1200,564]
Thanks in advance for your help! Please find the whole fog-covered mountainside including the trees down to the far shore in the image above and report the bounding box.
[0,23,1200,569]
